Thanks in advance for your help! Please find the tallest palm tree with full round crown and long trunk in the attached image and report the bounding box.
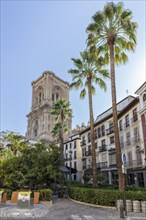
[87,2,138,190]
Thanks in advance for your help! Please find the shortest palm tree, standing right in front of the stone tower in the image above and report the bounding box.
[51,98,73,165]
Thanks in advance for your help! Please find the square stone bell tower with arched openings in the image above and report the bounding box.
[26,71,71,143]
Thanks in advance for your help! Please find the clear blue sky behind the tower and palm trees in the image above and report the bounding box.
[0,0,146,134]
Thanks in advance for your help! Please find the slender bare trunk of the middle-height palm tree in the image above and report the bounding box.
[88,78,97,188]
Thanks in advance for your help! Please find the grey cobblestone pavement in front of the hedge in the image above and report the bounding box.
[0,199,146,220]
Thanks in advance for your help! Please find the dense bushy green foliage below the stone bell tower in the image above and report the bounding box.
[0,134,61,189]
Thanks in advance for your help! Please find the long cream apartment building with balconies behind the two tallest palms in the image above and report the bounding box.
[64,83,146,187]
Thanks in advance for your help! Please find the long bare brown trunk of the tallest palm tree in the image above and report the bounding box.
[109,43,124,191]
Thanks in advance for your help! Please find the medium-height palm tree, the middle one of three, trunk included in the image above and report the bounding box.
[68,50,108,187]
